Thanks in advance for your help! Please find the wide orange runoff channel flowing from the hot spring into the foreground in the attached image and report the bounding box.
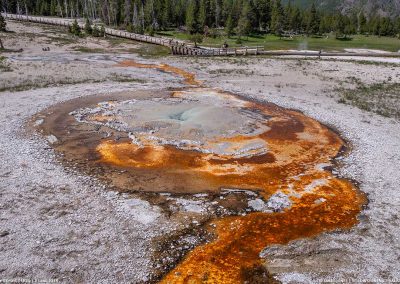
[161,174,364,283]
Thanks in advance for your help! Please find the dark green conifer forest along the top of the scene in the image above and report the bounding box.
[0,0,400,36]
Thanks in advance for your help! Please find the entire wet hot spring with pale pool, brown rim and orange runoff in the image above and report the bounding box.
[35,61,365,283]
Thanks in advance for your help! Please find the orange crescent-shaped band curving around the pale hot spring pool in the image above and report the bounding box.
[97,89,342,194]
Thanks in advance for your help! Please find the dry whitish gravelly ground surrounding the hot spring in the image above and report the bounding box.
[0,22,400,283]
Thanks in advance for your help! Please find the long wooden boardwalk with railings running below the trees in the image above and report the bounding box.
[2,13,400,58]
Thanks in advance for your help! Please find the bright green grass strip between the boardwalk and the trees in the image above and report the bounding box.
[158,31,400,52]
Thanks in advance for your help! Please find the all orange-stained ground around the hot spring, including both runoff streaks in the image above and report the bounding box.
[97,61,365,283]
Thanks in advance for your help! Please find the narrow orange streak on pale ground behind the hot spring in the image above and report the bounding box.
[118,60,201,86]
